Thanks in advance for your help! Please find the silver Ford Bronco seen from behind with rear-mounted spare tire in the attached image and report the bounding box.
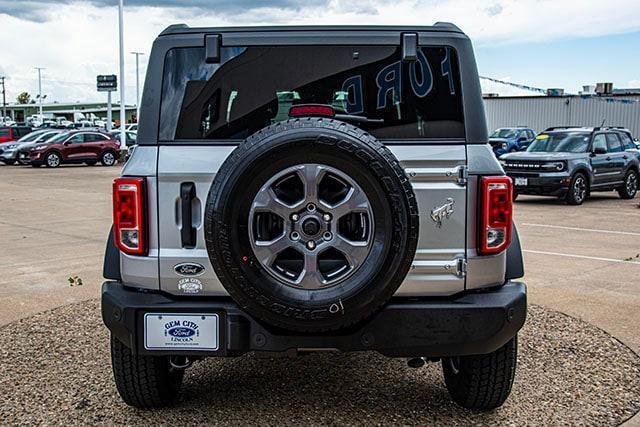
[102,24,526,410]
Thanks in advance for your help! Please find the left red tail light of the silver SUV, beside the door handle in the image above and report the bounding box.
[113,178,147,255]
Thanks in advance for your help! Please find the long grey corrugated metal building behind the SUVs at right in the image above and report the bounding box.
[484,94,640,138]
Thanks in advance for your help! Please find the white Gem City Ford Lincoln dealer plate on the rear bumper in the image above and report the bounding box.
[144,313,220,351]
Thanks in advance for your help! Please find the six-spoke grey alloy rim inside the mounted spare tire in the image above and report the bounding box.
[249,164,374,290]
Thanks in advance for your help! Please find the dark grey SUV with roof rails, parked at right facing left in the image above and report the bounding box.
[500,126,640,205]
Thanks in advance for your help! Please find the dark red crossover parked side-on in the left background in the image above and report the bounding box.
[29,131,120,168]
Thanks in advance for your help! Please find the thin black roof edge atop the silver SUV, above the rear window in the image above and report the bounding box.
[160,22,464,36]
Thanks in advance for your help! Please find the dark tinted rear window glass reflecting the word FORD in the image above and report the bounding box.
[159,46,464,141]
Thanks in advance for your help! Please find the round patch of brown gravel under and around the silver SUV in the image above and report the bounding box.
[0,301,640,425]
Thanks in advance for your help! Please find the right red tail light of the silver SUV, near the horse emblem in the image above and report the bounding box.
[478,176,513,255]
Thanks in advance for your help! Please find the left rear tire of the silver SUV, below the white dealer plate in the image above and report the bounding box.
[111,336,184,408]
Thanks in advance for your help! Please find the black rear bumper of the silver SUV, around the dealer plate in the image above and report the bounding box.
[102,282,527,357]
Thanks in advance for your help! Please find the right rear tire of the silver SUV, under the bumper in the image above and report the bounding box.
[442,336,518,411]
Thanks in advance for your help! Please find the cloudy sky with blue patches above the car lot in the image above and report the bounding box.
[0,0,640,103]
